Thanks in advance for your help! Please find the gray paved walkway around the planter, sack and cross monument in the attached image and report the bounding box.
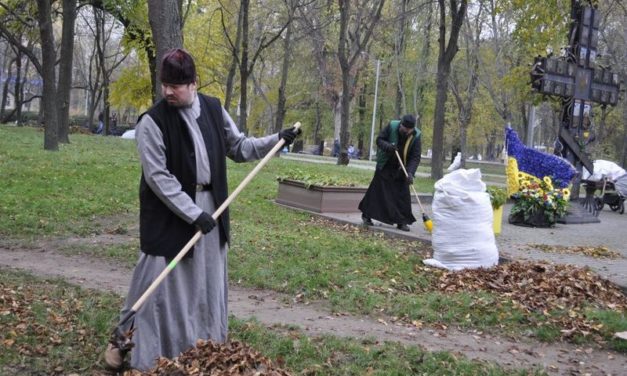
[292,202,627,293]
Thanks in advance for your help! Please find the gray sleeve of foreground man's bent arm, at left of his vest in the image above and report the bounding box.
[135,115,202,223]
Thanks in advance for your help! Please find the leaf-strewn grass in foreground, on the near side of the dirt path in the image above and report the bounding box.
[0,269,542,376]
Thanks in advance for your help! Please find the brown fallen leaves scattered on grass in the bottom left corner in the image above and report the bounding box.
[0,281,114,375]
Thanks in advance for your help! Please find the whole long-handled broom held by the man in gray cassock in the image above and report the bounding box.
[105,122,301,369]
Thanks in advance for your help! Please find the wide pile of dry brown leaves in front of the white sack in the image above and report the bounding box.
[438,262,627,336]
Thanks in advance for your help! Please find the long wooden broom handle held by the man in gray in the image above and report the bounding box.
[131,122,301,312]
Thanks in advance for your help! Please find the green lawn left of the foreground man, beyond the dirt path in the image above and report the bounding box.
[0,126,139,237]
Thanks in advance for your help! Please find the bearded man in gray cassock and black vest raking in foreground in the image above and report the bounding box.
[105,49,297,371]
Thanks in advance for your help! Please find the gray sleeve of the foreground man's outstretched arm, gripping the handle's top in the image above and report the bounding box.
[222,108,279,162]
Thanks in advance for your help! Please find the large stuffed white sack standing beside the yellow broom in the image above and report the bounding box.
[423,169,499,270]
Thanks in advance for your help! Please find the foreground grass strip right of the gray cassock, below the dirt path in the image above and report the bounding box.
[229,319,543,376]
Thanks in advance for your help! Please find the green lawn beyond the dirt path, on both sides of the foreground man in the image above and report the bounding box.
[0,127,627,352]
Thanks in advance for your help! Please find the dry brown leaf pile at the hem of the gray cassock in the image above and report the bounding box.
[124,340,289,376]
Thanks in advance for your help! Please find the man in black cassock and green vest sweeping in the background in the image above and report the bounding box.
[359,115,421,231]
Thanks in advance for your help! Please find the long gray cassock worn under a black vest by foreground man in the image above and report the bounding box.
[121,96,278,371]
